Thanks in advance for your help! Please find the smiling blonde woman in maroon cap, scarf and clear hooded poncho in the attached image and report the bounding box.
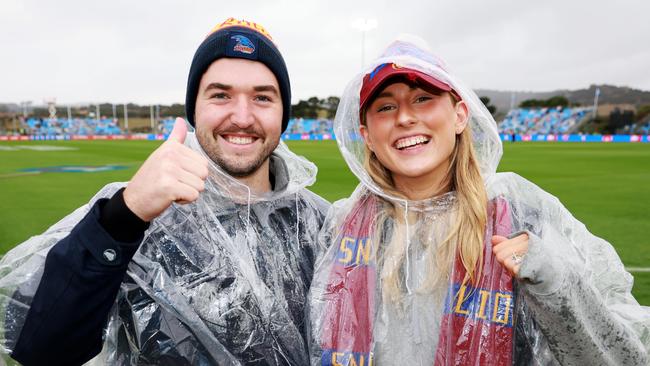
[310,40,650,366]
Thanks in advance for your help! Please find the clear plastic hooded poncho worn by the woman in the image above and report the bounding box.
[310,35,650,366]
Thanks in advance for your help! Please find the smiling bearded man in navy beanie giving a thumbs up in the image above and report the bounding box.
[0,19,328,365]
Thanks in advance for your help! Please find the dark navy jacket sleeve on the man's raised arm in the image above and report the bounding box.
[6,192,144,365]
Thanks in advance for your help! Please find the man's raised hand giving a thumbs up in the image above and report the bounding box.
[124,118,208,222]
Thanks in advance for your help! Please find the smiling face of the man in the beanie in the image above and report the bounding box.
[194,58,282,177]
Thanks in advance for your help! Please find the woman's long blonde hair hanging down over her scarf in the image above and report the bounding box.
[362,94,487,302]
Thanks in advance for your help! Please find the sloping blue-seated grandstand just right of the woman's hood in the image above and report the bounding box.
[499,107,593,134]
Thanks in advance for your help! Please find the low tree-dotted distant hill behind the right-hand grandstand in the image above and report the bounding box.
[476,85,650,114]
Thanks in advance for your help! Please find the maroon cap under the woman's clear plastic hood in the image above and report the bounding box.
[359,63,462,110]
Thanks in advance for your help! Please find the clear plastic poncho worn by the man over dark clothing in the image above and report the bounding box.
[0,133,329,365]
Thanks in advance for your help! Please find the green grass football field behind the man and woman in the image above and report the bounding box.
[0,141,650,305]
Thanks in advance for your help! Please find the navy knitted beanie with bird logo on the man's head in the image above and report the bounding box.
[185,18,291,132]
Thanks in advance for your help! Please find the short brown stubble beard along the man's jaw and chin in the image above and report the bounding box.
[196,129,280,178]
